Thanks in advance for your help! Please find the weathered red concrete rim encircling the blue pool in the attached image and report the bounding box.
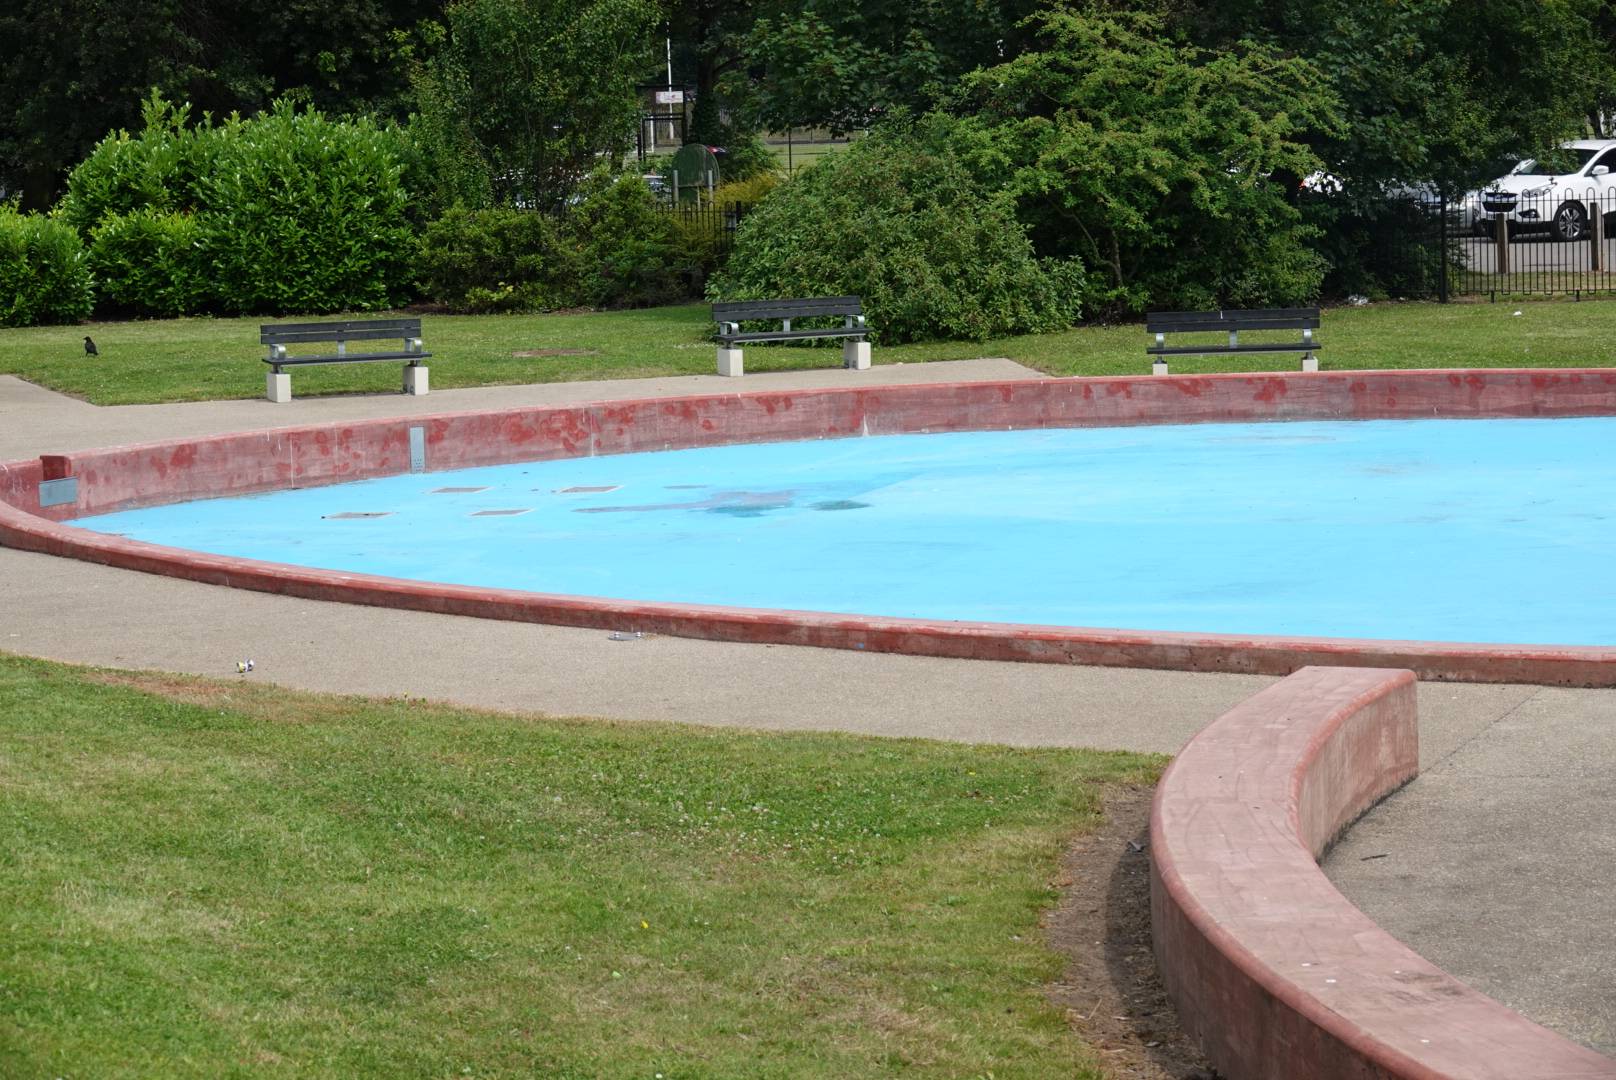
[0,370,1616,686]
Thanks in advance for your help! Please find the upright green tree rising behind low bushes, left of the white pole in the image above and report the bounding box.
[415,0,661,209]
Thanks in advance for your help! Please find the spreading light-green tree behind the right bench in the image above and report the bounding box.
[965,10,1336,312]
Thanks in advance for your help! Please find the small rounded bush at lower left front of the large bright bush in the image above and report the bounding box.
[90,207,213,315]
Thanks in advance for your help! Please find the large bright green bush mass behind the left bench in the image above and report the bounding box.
[58,94,419,314]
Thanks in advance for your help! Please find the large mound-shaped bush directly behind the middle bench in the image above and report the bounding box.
[709,118,1084,343]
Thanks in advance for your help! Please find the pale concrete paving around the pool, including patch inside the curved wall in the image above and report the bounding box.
[0,359,1616,1049]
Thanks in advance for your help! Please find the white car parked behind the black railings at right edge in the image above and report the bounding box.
[1464,139,1616,239]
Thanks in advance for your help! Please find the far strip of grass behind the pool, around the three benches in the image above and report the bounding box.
[0,299,1616,404]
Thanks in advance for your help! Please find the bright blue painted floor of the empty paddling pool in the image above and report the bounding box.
[74,417,1616,645]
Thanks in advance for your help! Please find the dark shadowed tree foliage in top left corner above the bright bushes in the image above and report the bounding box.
[0,0,443,209]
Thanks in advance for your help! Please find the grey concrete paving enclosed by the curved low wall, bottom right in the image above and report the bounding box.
[1324,687,1616,1057]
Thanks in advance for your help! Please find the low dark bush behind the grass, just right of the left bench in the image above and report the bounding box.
[422,209,582,312]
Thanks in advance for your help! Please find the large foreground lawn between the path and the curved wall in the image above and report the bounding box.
[0,655,1162,1080]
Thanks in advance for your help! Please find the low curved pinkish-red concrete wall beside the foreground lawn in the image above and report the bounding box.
[1151,668,1616,1080]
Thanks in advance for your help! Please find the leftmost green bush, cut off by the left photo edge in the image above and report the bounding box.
[0,202,94,327]
